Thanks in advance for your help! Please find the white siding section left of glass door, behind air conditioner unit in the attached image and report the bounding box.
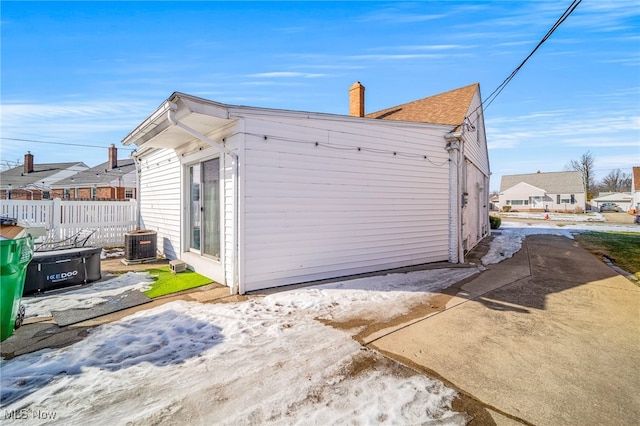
[140,149,181,259]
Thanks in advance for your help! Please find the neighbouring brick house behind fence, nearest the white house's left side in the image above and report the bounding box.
[51,144,137,201]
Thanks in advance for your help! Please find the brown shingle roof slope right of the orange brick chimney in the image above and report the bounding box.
[365,83,479,126]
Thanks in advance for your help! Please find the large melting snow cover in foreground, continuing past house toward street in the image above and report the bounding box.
[0,222,638,425]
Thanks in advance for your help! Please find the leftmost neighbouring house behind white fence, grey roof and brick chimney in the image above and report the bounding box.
[0,152,88,200]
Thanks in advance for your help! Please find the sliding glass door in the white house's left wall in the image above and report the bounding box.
[189,158,220,259]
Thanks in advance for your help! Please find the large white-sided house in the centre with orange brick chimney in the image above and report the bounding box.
[123,83,490,293]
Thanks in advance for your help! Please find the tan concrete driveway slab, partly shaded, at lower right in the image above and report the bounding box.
[363,235,640,425]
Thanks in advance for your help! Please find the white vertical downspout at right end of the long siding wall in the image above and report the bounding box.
[444,132,464,263]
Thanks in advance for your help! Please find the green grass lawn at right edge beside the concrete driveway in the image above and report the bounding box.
[575,232,640,279]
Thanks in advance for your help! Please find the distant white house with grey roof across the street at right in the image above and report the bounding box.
[500,172,587,213]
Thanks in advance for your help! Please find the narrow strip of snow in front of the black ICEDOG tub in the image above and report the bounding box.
[22,272,153,318]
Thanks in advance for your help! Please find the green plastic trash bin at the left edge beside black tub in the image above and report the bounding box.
[0,236,33,342]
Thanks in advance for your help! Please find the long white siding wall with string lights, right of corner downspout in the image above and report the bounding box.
[236,117,449,291]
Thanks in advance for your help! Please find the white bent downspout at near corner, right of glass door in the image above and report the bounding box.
[167,102,245,294]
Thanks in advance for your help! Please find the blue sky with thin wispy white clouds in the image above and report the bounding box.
[0,0,640,190]
